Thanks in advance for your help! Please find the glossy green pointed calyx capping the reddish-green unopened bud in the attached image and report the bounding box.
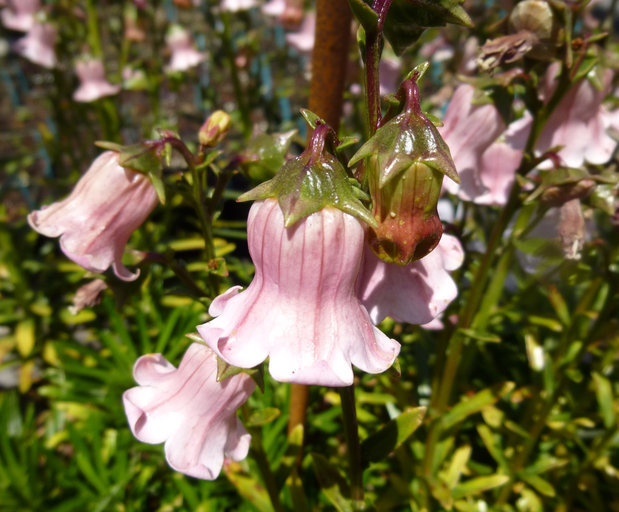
[348,79,460,188]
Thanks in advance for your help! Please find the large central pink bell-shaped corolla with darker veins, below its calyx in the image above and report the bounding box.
[198,199,400,386]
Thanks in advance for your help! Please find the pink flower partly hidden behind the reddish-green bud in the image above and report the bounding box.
[357,235,464,324]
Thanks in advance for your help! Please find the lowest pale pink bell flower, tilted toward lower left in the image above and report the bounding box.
[123,343,255,480]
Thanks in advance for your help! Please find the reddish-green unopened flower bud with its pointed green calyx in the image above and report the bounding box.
[349,79,460,265]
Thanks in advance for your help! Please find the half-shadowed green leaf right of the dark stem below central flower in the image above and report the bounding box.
[361,407,426,465]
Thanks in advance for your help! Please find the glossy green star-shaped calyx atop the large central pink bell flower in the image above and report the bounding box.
[238,123,376,227]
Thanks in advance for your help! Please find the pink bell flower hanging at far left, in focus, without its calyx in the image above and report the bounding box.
[28,151,158,281]
